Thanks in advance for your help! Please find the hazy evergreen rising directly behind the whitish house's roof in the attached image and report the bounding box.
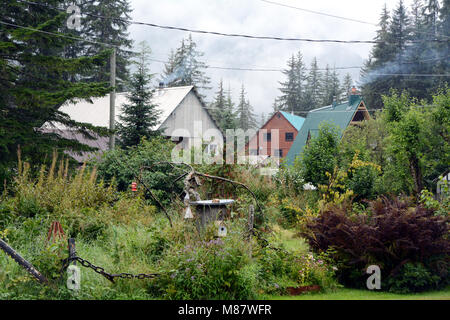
[162,35,211,98]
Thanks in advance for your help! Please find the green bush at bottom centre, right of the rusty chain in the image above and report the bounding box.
[149,238,256,300]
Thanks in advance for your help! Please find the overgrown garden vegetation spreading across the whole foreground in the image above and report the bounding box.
[0,89,450,299]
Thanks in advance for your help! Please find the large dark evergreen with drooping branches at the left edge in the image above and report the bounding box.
[0,0,110,181]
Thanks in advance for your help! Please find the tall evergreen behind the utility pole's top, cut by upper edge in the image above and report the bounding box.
[79,0,133,91]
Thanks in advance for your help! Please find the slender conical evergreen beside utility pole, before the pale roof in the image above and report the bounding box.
[117,42,160,147]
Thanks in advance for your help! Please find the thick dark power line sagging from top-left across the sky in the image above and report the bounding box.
[17,0,443,44]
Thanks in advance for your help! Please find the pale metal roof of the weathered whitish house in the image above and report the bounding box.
[44,86,194,129]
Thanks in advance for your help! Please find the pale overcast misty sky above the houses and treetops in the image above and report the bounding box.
[129,0,411,114]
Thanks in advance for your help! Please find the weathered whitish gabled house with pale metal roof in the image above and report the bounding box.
[43,86,223,162]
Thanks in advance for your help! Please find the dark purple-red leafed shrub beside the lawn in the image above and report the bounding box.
[303,197,450,292]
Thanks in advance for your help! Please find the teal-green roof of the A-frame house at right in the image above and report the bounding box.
[285,95,364,165]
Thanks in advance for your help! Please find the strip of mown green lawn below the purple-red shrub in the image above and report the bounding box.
[261,287,450,300]
